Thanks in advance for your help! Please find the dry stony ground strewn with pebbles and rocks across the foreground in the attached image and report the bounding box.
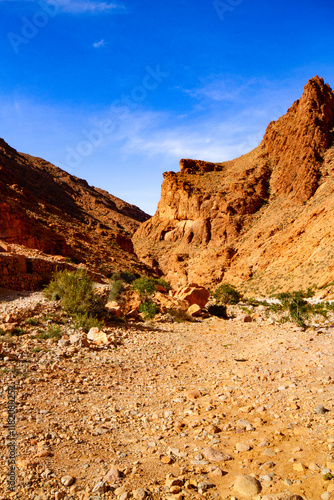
[0,294,334,500]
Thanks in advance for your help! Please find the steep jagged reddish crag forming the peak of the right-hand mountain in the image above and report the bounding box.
[261,77,334,202]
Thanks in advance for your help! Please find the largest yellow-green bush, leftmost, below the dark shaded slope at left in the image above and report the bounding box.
[43,269,98,315]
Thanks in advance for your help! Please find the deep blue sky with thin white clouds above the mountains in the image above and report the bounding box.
[0,0,334,214]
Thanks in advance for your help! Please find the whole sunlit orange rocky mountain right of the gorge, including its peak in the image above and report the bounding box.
[134,77,334,292]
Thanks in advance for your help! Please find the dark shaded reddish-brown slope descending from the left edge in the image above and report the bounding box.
[0,139,149,273]
